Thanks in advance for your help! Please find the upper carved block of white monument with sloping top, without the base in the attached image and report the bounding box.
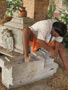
[0,12,34,54]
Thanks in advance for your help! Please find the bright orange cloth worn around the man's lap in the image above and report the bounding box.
[29,34,55,52]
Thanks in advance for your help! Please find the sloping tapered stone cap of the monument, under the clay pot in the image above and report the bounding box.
[4,17,34,29]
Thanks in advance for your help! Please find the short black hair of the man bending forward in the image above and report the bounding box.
[53,21,67,37]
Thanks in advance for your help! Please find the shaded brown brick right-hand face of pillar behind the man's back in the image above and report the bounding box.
[34,0,49,21]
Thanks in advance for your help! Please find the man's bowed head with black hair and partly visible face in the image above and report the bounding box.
[52,21,67,37]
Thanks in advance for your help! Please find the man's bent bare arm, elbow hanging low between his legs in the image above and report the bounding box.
[37,39,59,57]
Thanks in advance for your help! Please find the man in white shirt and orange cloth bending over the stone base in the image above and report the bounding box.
[23,20,68,71]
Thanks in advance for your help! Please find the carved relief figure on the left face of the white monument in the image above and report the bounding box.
[0,28,14,51]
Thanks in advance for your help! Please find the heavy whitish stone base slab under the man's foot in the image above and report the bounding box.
[0,56,58,88]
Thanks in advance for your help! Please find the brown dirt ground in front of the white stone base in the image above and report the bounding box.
[0,49,68,90]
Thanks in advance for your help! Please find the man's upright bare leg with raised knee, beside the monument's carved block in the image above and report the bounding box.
[23,27,33,60]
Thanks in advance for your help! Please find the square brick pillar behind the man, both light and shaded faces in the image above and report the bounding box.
[23,0,49,21]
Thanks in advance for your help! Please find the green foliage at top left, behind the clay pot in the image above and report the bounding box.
[6,0,22,16]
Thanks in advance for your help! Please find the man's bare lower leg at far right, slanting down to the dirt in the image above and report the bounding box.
[59,44,68,71]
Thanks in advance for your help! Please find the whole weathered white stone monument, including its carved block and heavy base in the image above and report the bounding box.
[0,9,58,88]
